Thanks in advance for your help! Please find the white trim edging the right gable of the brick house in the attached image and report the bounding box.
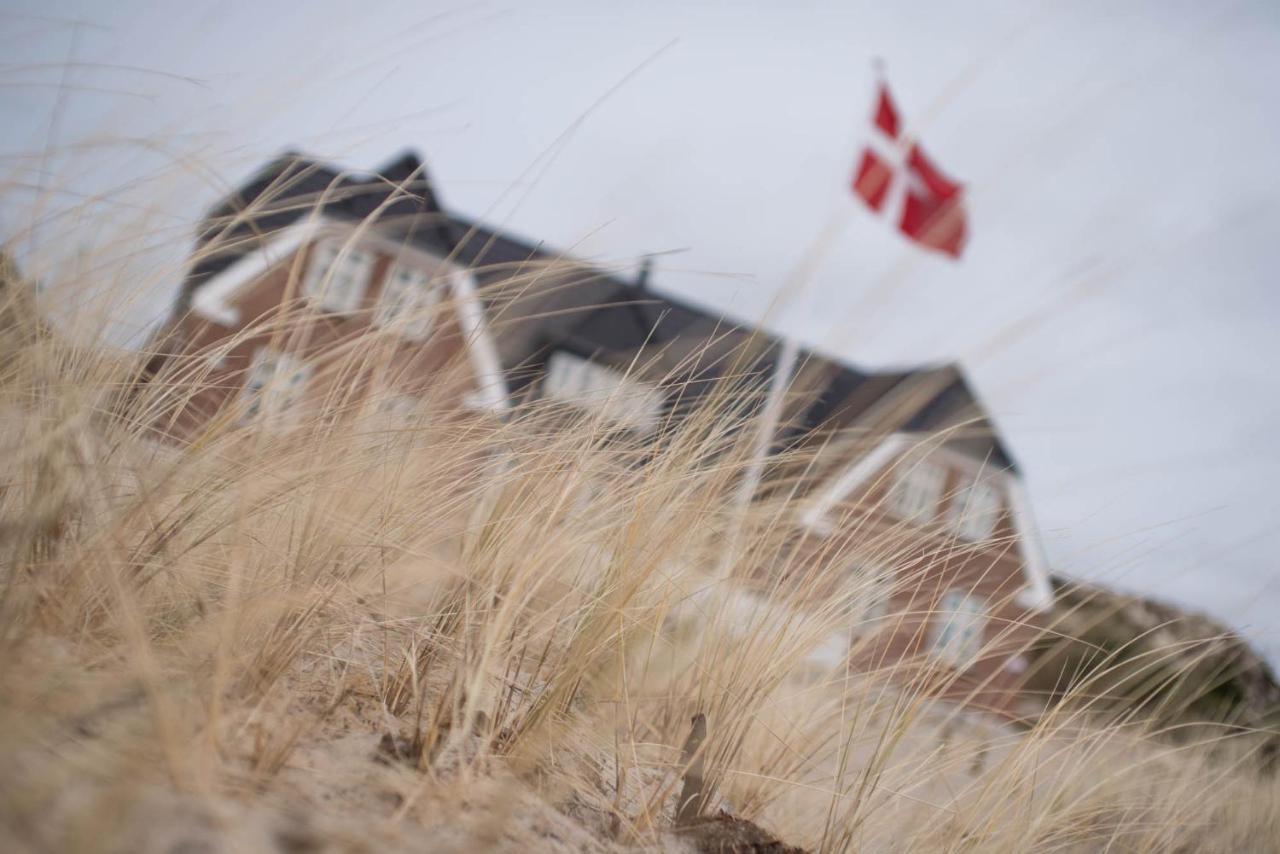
[800,433,1053,611]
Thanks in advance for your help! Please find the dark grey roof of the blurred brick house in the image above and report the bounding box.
[178,152,1014,469]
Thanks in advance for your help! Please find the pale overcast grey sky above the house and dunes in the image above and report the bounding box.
[0,0,1280,658]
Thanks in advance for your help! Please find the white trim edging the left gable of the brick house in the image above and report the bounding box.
[191,216,511,412]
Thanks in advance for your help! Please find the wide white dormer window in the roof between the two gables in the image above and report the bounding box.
[543,350,666,433]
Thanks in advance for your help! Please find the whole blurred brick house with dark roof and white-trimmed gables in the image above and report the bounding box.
[150,154,1052,711]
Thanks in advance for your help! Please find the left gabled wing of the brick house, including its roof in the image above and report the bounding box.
[148,149,507,440]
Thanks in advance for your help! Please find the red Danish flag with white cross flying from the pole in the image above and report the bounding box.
[852,82,966,257]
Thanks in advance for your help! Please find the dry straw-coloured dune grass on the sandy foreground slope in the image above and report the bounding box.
[0,229,1280,853]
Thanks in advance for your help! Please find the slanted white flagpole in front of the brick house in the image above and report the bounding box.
[721,205,854,579]
